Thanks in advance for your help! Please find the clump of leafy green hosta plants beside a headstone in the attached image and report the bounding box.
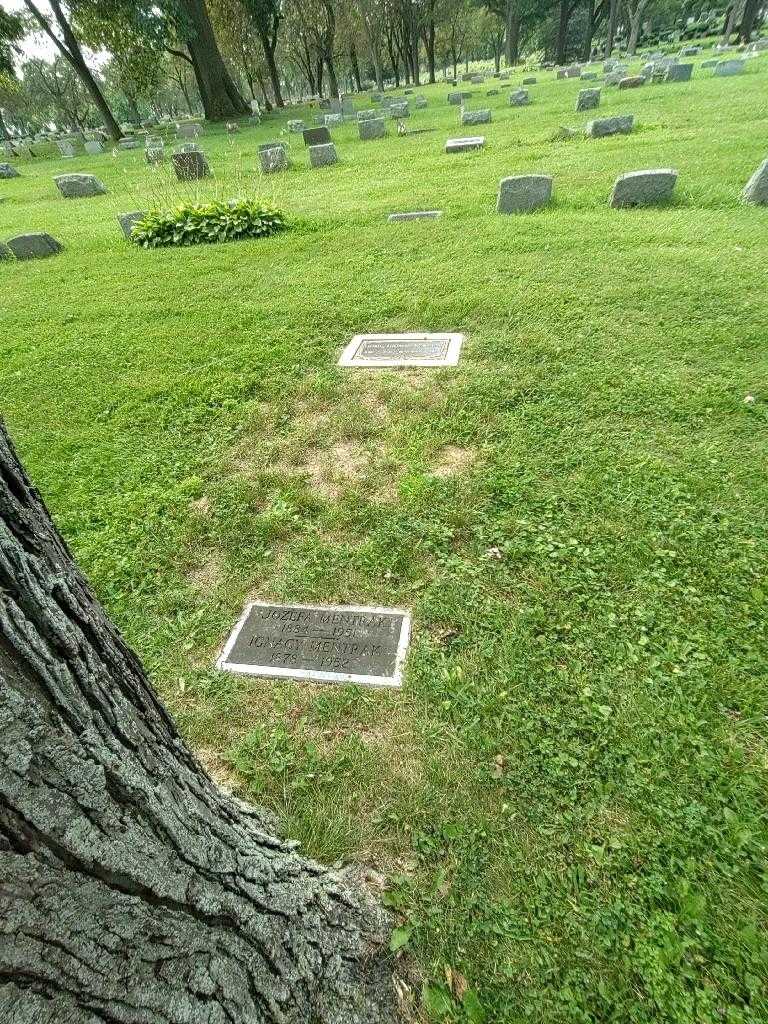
[131,200,287,249]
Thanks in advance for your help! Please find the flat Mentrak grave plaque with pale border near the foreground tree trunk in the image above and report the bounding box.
[216,601,411,687]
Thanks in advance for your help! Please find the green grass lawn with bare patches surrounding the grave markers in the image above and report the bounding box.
[0,49,768,1024]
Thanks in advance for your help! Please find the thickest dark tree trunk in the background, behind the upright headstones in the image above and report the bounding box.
[178,0,249,121]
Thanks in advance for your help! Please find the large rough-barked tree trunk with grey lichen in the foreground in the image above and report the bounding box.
[0,424,396,1024]
